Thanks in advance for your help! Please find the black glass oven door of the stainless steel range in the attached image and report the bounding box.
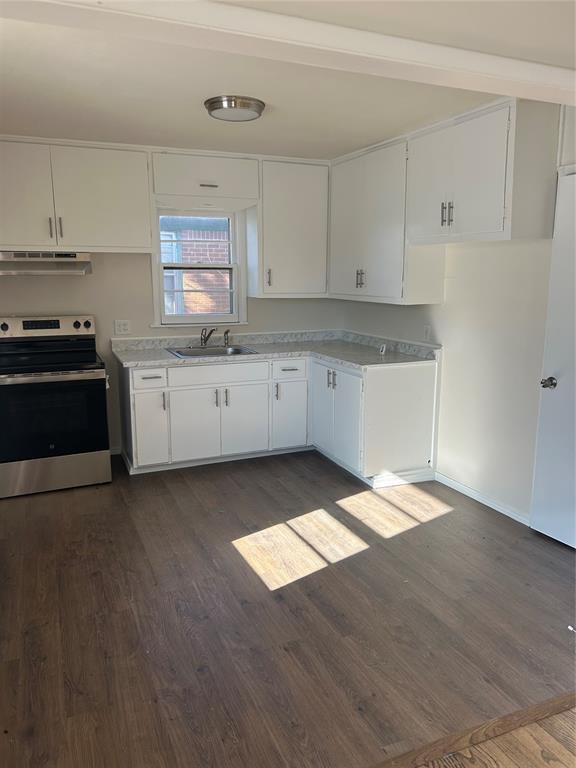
[0,370,108,463]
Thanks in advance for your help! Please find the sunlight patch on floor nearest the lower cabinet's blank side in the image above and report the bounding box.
[336,484,453,539]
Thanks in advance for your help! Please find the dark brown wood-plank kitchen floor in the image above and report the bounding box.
[0,453,574,768]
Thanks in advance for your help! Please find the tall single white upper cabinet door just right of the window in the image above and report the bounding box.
[262,160,328,294]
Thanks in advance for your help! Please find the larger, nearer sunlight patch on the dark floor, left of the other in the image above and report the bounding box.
[232,509,368,590]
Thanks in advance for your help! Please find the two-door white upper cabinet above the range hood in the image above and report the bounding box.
[0,141,152,252]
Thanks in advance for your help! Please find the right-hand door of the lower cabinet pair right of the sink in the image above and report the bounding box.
[332,371,362,470]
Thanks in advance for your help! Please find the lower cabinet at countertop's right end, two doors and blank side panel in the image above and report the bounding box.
[310,360,436,480]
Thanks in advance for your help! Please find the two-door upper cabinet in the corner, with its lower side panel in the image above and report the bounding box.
[329,141,444,304]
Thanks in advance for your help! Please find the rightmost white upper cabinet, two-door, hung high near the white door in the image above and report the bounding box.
[407,101,559,244]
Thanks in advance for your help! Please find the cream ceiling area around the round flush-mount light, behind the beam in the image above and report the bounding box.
[0,17,493,158]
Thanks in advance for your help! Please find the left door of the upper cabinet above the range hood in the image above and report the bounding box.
[0,141,56,249]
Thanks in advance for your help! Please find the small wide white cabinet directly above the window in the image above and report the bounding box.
[152,152,258,200]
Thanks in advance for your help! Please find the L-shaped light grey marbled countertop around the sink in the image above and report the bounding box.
[113,340,433,369]
